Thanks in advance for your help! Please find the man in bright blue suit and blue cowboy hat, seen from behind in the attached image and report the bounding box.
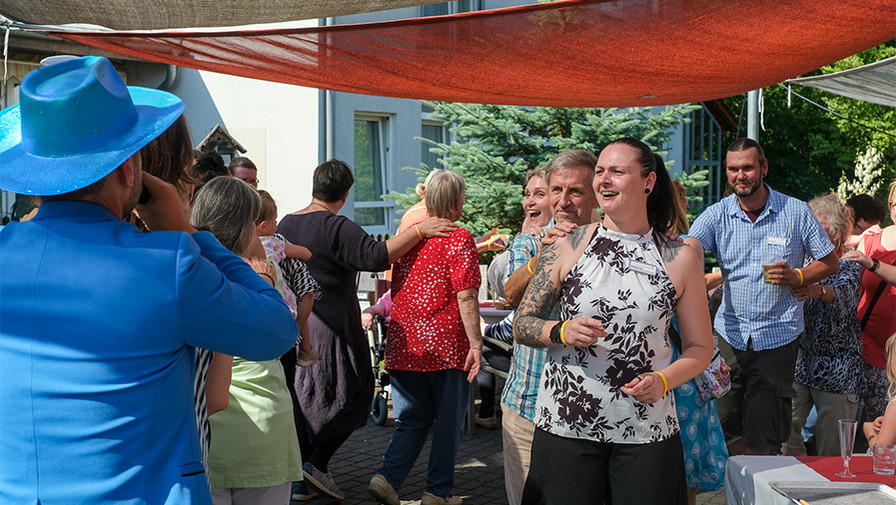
[0,57,298,505]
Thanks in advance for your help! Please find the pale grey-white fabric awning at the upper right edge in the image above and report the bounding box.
[784,56,896,107]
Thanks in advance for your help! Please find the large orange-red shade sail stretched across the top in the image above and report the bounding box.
[51,0,896,107]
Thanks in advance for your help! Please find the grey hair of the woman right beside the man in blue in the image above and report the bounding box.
[190,176,261,254]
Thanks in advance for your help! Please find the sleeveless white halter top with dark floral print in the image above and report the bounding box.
[535,224,678,444]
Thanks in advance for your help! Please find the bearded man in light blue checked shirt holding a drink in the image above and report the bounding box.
[691,138,838,455]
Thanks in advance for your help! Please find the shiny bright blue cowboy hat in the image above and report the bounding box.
[0,56,184,195]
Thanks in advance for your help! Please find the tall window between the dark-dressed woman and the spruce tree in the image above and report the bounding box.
[354,115,393,227]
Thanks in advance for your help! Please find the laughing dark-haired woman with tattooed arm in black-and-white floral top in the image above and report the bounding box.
[513,138,712,505]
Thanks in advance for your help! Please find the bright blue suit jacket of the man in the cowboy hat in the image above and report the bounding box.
[0,202,298,505]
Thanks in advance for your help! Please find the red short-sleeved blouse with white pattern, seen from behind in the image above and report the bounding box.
[386,228,482,372]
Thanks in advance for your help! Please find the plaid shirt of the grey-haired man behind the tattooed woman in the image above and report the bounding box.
[501,233,547,421]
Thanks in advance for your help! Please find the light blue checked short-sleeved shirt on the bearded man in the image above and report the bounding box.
[690,186,834,351]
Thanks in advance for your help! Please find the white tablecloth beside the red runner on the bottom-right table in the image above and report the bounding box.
[725,456,828,505]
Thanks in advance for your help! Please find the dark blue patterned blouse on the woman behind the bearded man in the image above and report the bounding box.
[793,259,865,394]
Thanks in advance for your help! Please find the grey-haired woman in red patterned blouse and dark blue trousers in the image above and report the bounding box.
[368,170,482,505]
